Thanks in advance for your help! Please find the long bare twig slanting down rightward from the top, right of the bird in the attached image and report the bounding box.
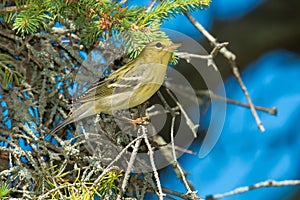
[184,12,265,132]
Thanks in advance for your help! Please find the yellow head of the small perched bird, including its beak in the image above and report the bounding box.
[141,40,180,65]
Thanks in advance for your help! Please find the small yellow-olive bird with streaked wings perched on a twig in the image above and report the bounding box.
[49,40,180,135]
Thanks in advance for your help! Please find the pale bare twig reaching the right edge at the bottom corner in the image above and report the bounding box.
[208,180,300,200]
